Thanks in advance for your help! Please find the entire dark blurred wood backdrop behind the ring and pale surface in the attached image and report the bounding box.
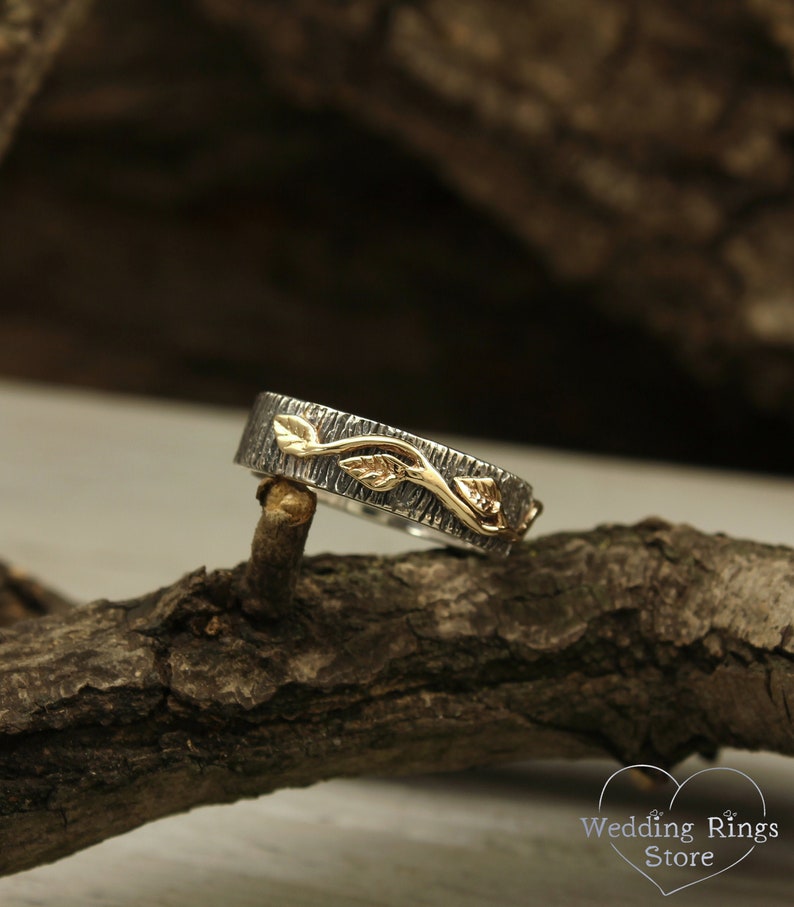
[0,0,794,472]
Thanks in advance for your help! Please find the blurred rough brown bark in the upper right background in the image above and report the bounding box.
[197,0,794,417]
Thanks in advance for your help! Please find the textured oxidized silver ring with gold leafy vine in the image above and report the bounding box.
[234,392,542,556]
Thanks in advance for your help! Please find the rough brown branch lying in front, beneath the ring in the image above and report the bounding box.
[0,508,794,873]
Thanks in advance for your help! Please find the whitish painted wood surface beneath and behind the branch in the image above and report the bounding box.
[0,382,794,907]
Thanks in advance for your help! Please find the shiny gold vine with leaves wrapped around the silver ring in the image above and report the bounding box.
[273,413,540,541]
